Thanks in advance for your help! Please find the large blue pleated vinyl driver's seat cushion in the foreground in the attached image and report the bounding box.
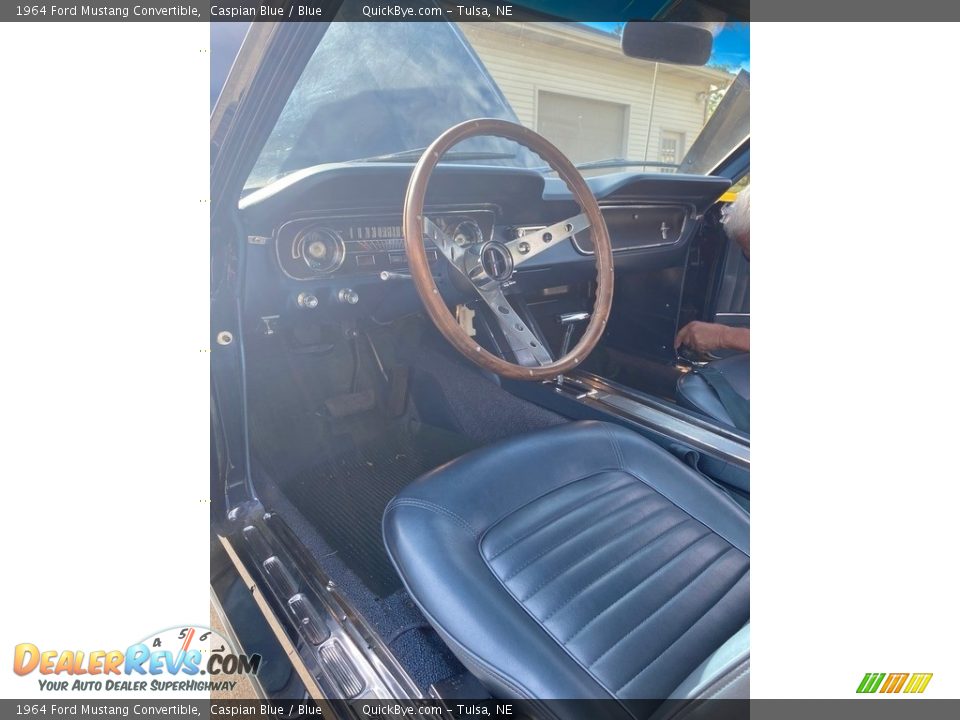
[384,422,750,699]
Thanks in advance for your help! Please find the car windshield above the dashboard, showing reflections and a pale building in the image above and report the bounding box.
[246,22,750,189]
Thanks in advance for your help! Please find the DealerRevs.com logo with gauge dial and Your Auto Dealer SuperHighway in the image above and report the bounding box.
[13,626,261,692]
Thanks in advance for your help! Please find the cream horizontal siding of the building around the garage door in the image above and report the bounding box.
[460,23,732,169]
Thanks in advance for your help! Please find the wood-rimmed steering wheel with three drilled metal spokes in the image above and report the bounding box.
[403,118,613,380]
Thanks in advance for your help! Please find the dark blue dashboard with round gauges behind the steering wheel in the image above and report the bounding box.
[240,163,729,325]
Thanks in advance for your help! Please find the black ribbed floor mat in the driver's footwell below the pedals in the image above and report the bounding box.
[281,425,475,598]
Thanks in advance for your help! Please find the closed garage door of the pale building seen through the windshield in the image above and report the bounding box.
[537,91,627,163]
